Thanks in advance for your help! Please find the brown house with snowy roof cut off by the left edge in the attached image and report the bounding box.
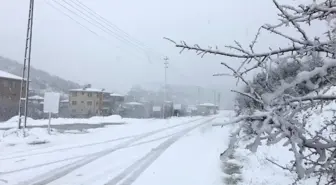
[0,70,26,121]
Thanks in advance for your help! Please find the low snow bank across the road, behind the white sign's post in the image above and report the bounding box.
[0,115,126,128]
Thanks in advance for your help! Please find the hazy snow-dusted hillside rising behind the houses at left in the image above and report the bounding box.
[0,56,80,92]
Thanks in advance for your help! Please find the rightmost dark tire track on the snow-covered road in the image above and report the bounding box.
[105,118,215,185]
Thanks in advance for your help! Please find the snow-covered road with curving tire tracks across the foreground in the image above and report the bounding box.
[0,114,229,185]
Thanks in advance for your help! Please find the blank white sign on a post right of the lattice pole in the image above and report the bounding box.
[43,92,60,114]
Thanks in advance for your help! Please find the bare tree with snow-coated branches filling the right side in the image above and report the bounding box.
[165,0,336,184]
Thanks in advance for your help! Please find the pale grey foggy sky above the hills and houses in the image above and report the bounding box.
[0,0,322,106]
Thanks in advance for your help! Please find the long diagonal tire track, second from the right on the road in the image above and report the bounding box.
[18,118,206,185]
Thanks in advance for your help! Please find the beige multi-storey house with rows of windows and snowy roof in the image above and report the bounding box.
[69,85,110,118]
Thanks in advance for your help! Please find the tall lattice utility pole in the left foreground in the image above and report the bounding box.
[18,0,34,129]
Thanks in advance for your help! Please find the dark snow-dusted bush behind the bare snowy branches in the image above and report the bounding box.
[236,54,326,114]
